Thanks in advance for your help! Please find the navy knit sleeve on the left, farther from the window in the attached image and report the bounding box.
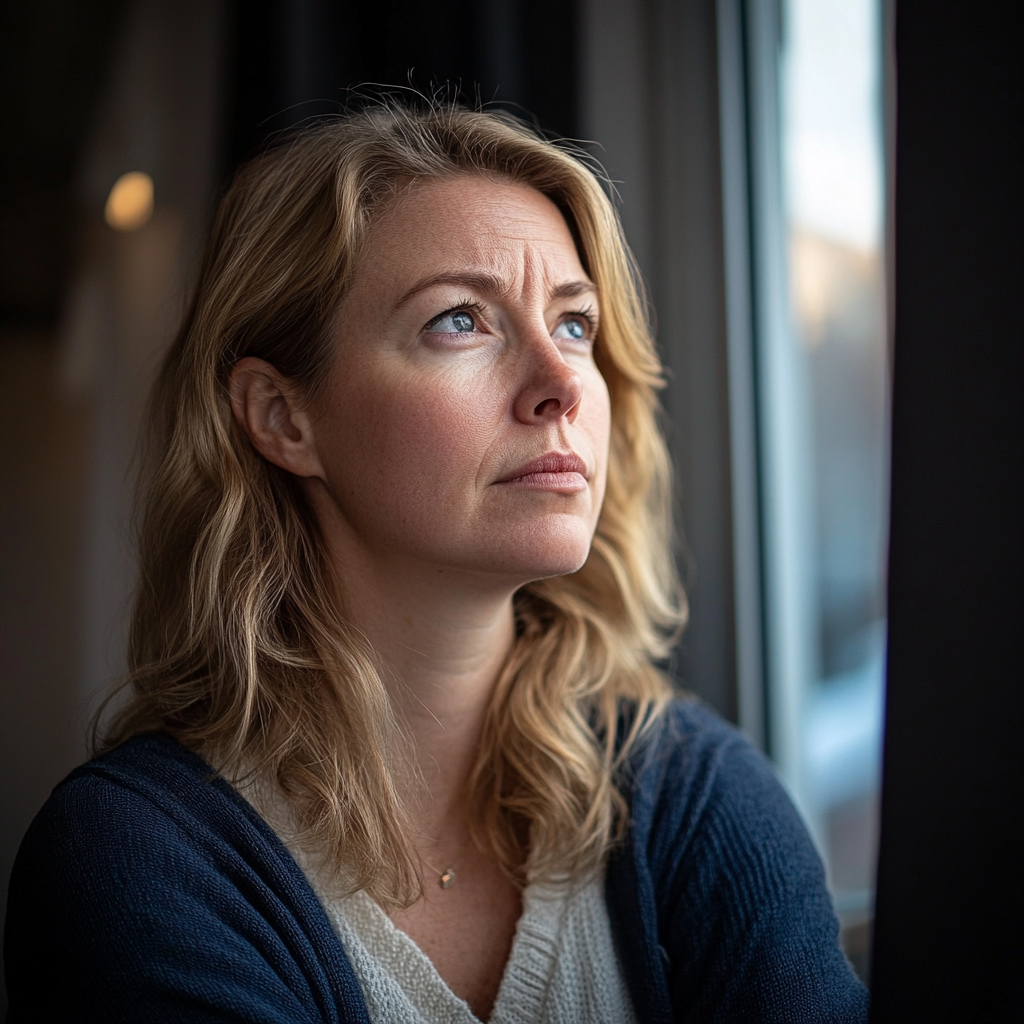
[4,737,367,1024]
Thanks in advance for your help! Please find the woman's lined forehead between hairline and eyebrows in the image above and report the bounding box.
[357,174,587,283]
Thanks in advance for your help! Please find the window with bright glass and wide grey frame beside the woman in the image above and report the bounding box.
[581,0,888,967]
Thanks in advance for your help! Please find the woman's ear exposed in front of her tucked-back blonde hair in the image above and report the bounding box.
[227,355,324,478]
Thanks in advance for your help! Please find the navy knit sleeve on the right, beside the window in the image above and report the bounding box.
[610,703,867,1024]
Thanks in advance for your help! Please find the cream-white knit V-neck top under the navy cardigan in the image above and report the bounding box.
[240,770,636,1024]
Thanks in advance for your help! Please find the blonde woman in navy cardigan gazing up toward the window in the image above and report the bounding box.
[7,103,865,1022]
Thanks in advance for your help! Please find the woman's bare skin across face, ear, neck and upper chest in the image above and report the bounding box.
[231,175,610,1019]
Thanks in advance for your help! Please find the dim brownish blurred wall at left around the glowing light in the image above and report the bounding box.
[0,0,223,1007]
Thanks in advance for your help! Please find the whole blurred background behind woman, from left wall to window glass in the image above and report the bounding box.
[0,0,892,1003]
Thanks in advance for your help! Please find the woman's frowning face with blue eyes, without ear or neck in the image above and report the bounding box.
[313,175,610,587]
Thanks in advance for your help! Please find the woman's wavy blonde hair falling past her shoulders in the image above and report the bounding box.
[102,99,685,906]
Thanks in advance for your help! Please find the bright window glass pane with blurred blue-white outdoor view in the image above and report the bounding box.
[758,0,888,974]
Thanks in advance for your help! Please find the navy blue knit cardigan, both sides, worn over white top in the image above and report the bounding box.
[5,701,867,1024]
